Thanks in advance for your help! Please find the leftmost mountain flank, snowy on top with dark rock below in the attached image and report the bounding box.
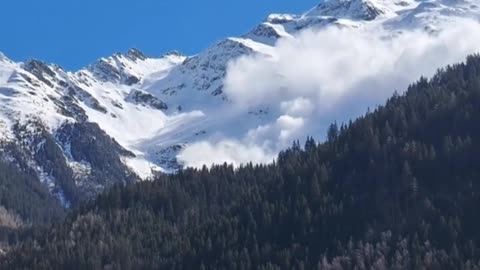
[0,59,142,206]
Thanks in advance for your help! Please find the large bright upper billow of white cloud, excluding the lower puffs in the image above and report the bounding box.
[225,21,480,111]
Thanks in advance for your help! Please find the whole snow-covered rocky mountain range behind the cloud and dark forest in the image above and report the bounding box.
[0,0,480,205]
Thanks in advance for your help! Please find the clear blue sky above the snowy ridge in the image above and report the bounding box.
[0,0,320,70]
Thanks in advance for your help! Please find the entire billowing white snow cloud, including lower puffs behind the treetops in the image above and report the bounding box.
[178,19,480,167]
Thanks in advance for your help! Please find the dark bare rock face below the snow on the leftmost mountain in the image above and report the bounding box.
[3,121,138,206]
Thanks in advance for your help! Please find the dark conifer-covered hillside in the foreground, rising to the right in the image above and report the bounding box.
[0,55,480,269]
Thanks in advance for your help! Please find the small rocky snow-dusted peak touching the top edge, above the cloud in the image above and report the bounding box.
[305,0,391,21]
